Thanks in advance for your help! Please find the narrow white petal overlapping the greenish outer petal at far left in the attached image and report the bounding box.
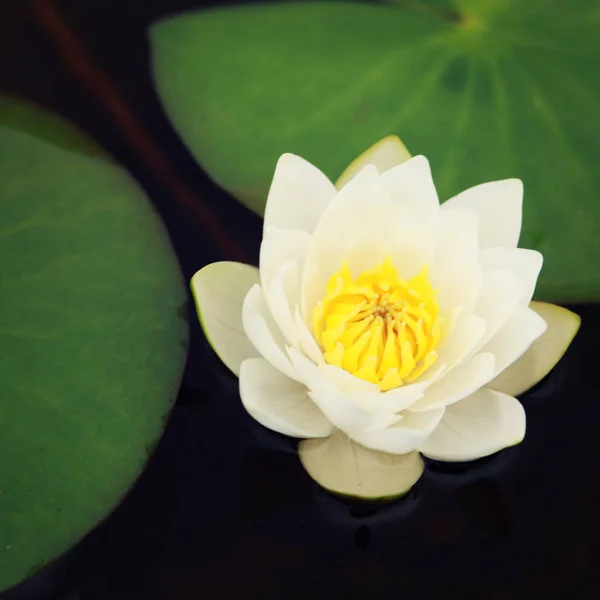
[242,285,300,381]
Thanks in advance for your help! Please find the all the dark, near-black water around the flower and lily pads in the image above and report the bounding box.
[0,0,600,600]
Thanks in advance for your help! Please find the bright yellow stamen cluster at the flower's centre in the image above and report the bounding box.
[313,258,441,391]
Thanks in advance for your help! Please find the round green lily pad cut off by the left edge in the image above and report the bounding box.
[0,99,187,589]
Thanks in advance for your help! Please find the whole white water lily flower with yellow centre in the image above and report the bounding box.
[192,136,579,498]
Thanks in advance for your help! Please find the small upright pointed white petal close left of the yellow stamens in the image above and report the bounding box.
[262,260,300,348]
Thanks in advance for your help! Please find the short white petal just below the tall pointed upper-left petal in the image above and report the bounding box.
[259,229,312,288]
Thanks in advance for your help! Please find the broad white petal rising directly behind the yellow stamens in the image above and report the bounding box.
[302,165,433,323]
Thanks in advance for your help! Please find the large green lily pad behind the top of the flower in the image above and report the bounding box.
[151,0,600,301]
